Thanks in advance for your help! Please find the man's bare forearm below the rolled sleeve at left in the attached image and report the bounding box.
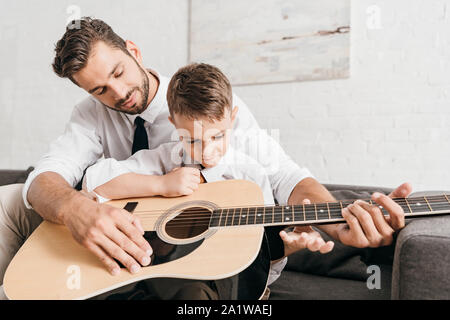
[27,172,86,224]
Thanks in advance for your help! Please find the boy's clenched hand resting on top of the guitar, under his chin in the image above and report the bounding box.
[161,167,200,197]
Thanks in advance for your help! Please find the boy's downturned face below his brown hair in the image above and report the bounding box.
[169,107,238,168]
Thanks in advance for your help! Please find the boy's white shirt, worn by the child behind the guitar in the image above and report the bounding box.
[83,142,287,285]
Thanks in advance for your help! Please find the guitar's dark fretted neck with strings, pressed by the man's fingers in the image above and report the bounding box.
[209,194,450,228]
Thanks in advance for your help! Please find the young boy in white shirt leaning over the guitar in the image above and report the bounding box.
[83,64,333,300]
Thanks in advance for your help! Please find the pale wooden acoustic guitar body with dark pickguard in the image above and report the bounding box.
[3,180,270,299]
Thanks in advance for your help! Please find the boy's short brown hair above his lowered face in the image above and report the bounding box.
[167,63,233,121]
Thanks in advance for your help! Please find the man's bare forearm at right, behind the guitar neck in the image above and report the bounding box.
[288,178,338,240]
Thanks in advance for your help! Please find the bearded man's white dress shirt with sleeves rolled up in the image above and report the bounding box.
[23,70,312,208]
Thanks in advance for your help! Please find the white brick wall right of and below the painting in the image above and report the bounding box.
[235,0,450,190]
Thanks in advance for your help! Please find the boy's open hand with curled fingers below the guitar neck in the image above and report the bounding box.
[280,199,334,257]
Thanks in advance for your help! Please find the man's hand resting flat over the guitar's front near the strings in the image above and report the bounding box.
[64,196,152,275]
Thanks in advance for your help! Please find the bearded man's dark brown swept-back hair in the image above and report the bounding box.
[52,17,130,83]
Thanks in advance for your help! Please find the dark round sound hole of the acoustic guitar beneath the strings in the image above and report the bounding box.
[166,207,211,239]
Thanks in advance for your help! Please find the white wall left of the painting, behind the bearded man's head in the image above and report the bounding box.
[0,0,188,169]
